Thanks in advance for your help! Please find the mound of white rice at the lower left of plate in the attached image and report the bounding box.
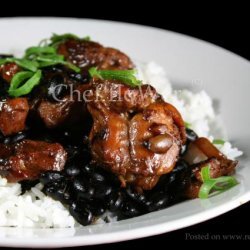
[0,177,75,228]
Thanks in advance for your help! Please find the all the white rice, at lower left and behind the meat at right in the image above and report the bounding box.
[0,62,242,228]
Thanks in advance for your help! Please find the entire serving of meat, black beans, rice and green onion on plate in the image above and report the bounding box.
[0,34,241,227]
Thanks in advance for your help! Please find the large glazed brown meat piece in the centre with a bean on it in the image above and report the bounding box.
[87,80,185,189]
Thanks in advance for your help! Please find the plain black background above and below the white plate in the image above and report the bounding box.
[1,0,250,245]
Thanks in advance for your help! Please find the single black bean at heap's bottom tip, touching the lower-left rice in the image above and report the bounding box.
[69,202,93,226]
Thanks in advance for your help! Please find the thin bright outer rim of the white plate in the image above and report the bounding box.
[0,17,250,248]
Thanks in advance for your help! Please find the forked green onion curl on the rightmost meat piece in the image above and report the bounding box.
[198,165,238,199]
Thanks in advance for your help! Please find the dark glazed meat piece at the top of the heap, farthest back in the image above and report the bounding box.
[58,39,133,70]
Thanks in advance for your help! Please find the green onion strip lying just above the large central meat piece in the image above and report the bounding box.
[89,67,142,87]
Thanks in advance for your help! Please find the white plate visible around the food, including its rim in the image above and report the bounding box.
[0,18,250,247]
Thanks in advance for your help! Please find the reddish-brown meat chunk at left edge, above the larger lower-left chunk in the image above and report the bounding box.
[0,98,29,136]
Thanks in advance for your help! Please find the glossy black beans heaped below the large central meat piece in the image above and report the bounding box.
[36,138,188,225]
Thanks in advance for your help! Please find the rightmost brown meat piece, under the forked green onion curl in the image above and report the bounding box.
[184,137,238,199]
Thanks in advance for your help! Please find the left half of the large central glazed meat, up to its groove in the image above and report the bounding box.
[88,103,130,175]
